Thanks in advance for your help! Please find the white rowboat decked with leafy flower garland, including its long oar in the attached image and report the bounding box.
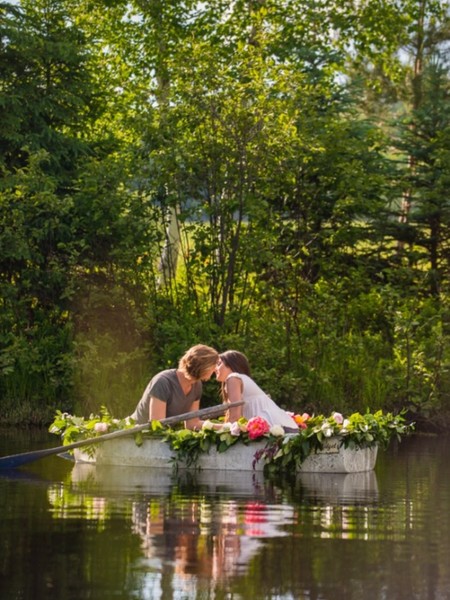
[0,401,414,474]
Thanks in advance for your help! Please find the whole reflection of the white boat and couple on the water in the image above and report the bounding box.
[47,464,378,593]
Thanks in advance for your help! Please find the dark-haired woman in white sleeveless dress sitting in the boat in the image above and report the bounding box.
[216,350,298,433]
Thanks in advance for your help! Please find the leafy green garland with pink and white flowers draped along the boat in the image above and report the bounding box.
[49,407,414,472]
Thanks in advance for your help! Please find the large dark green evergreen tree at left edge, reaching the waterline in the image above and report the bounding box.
[0,0,158,419]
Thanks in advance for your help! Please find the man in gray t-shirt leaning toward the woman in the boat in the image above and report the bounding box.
[131,344,219,429]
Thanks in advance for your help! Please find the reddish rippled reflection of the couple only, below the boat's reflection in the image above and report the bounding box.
[129,492,288,582]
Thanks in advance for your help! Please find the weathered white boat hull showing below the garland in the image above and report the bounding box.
[74,437,378,473]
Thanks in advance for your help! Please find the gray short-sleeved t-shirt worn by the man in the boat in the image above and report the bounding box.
[131,369,203,424]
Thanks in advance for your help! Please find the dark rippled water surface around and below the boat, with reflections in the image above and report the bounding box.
[0,430,450,600]
